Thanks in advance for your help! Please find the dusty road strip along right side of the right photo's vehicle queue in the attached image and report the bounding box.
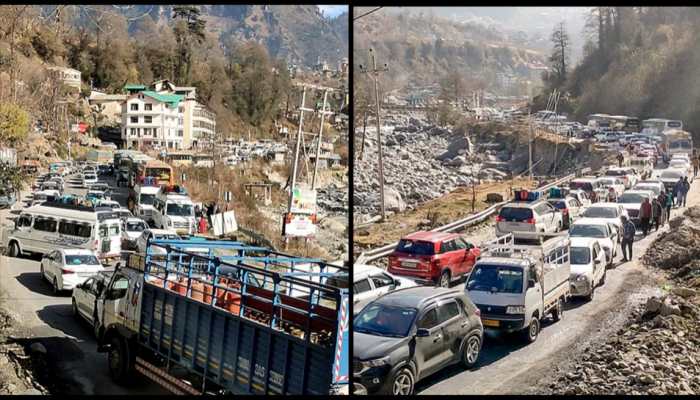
[416,172,700,394]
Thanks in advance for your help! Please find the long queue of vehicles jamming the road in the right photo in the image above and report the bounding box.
[352,130,698,395]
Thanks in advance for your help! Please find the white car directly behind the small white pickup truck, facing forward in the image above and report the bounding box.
[569,237,607,301]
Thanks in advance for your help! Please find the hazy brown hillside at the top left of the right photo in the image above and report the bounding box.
[353,9,544,94]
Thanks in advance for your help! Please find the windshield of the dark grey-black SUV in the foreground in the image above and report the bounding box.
[352,302,417,337]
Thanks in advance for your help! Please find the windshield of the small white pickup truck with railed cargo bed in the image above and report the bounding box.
[467,264,523,293]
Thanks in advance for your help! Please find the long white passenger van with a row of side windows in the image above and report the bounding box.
[2,202,121,259]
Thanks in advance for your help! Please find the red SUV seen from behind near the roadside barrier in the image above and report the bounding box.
[388,231,481,287]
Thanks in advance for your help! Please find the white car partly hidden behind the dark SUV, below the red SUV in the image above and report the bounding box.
[352,264,416,314]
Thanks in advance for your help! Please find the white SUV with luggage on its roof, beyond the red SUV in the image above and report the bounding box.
[496,200,564,239]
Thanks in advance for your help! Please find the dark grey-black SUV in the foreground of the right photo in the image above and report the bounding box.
[353,286,484,395]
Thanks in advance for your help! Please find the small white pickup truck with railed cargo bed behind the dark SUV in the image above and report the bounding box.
[464,232,571,343]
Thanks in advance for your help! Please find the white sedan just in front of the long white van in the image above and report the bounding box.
[41,249,104,294]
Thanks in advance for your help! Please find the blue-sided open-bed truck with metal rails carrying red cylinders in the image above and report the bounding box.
[95,238,350,395]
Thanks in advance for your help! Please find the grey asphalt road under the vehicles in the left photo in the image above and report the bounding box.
[0,171,169,395]
